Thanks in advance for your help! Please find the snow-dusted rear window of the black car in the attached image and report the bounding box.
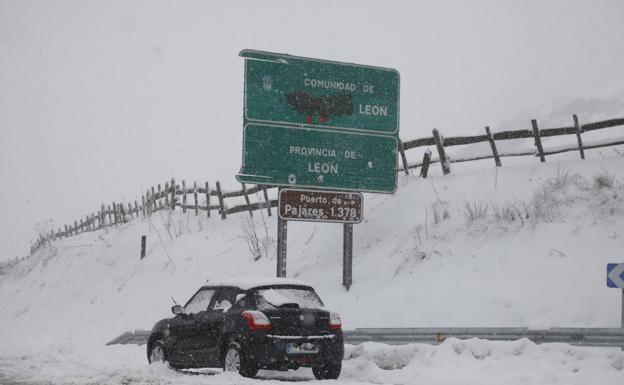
[257,287,323,310]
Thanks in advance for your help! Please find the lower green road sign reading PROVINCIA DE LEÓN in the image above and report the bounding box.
[236,123,397,193]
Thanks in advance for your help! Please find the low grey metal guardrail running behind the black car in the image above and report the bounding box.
[106,328,624,347]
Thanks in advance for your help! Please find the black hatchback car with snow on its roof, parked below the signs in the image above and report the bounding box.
[147,278,344,379]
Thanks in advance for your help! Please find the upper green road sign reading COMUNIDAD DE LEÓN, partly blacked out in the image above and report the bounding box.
[240,50,399,135]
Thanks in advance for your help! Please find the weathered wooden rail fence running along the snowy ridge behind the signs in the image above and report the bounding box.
[30,115,624,253]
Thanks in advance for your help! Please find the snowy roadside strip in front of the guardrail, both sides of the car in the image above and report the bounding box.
[0,339,624,385]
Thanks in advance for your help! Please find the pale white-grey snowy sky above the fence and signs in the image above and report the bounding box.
[0,0,624,260]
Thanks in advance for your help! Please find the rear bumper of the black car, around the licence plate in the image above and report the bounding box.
[243,333,344,370]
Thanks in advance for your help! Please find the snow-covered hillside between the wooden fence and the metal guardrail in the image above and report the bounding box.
[0,152,624,349]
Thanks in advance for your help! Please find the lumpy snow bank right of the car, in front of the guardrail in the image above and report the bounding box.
[342,338,624,385]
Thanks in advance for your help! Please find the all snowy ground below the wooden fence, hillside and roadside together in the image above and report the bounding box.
[0,149,624,384]
